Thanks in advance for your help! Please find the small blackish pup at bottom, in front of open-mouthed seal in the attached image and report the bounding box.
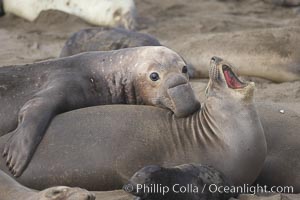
[123,164,234,200]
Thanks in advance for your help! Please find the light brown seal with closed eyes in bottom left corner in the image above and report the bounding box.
[0,170,95,200]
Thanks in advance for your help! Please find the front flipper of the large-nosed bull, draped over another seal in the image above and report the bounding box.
[3,85,69,177]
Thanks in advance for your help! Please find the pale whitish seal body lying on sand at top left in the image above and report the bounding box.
[4,0,136,29]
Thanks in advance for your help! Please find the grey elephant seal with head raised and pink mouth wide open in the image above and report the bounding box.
[0,58,266,191]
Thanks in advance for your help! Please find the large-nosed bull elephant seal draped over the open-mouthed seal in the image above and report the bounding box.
[0,47,200,176]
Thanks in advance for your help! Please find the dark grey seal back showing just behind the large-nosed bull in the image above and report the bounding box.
[60,27,161,57]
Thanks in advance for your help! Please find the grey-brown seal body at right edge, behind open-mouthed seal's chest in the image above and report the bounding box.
[256,103,300,193]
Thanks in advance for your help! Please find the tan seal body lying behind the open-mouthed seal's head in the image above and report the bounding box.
[164,27,300,82]
